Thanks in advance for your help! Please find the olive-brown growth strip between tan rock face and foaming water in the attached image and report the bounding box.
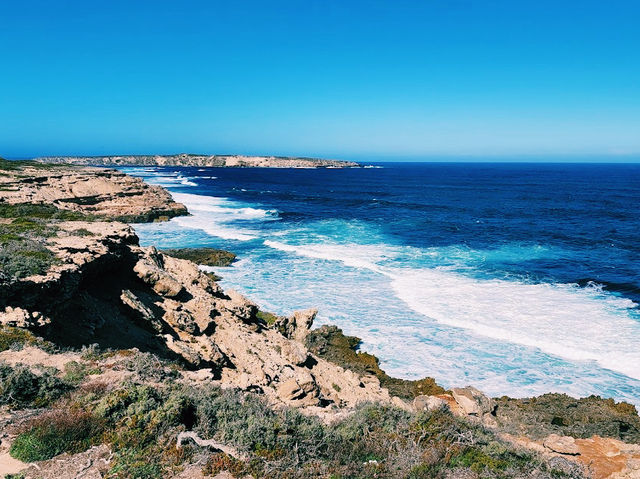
[306,326,445,399]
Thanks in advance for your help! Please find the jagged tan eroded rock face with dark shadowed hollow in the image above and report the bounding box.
[0,222,391,410]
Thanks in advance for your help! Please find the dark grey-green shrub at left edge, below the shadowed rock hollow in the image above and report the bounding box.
[0,363,71,408]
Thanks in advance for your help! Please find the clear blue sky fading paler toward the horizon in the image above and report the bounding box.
[0,0,640,161]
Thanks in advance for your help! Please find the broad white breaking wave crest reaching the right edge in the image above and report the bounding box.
[264,240,640,379]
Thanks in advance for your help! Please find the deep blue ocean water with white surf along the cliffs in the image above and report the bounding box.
[123,163,640,405]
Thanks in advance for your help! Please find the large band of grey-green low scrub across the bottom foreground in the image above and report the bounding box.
[0,338,583,479]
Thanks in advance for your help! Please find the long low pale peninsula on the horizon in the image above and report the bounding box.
[35,153,360,168]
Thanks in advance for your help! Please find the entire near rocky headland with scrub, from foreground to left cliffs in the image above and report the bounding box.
[0,158,640,479]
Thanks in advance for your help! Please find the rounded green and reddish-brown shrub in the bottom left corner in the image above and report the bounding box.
[9,410,103,462]
